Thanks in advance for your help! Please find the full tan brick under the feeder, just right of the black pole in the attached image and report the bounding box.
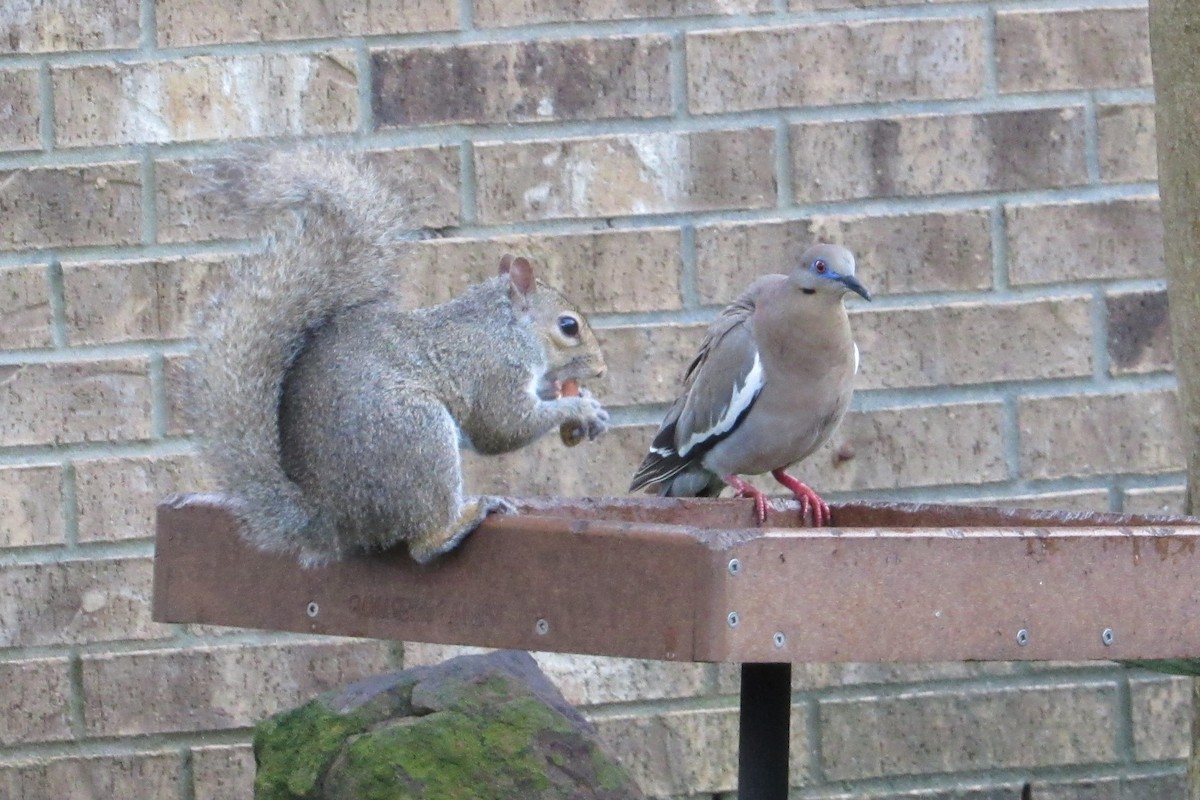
[820,685,1117,781]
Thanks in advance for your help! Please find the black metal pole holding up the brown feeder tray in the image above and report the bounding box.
[738,663,792,800]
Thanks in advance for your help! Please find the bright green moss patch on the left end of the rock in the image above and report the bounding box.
[254,699,367,800]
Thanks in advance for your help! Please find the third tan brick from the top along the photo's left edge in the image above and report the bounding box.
[0,164,142,249]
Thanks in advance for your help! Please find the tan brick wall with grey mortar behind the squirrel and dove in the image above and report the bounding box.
[0,0,1188,800]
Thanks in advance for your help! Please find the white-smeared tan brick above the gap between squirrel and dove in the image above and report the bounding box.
[475,128,775,223]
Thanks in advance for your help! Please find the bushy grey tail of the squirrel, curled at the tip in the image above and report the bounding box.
[187,150,412,552]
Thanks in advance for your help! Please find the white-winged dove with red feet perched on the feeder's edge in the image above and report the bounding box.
[630,245,871,527]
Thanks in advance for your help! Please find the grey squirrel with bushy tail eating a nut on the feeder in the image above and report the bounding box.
[185,150,608,566]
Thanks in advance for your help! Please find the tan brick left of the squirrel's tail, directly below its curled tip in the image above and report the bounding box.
[62,255,229,344]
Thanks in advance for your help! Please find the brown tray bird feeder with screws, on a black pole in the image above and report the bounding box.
[154,494,1200,800]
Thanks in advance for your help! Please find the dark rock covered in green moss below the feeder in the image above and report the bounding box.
[254,651,643,800]
